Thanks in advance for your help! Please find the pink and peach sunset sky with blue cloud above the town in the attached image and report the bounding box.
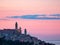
[0,0,60,40]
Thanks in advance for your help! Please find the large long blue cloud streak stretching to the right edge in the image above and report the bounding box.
[7,14,60,20]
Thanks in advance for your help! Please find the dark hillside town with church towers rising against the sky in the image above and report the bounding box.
[0,22,55,45]
